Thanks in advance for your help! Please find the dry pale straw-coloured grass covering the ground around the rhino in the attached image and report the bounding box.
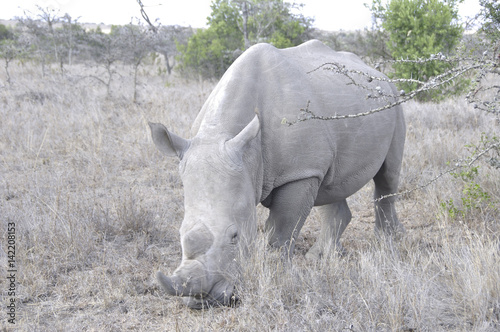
[0,64,500,331]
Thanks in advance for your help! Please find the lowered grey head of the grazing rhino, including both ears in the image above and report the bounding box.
[149,116,261,309]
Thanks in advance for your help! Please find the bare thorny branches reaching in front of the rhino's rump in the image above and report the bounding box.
[282,52,500,201]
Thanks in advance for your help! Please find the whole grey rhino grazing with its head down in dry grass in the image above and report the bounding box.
[150,41,405,308]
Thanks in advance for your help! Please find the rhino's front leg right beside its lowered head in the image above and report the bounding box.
[265,178,319,259]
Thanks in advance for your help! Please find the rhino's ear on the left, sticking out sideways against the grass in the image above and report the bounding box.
[149,122,191,159]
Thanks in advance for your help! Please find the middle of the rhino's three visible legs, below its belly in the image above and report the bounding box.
[306,199,352,260]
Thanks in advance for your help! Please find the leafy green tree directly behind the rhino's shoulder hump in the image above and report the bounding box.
[179,0,312,78]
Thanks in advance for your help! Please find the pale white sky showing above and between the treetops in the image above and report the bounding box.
[0,0,480,31]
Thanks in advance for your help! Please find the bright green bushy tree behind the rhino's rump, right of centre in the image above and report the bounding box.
[371,0,463,99]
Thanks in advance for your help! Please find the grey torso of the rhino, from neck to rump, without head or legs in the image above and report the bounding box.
[194,41,404,204]
